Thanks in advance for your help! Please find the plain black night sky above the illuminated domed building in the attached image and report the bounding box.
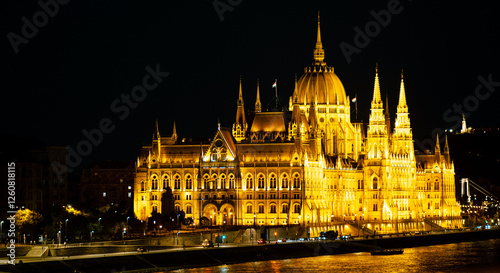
[0,0,500,168]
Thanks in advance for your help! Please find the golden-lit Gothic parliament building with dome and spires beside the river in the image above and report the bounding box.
[134,18,462,236]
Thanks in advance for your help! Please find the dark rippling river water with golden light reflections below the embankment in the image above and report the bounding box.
[169,239,500,273]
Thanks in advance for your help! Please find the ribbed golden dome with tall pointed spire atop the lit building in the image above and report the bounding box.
[297,14,347,104]
